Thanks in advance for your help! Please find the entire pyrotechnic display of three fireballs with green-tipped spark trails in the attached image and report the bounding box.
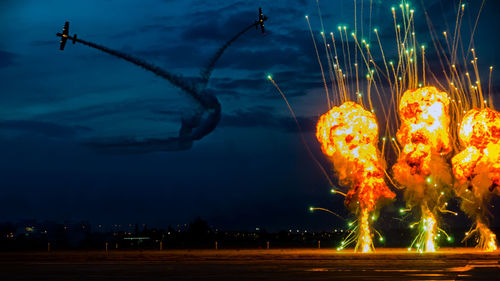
[270,1,500,253]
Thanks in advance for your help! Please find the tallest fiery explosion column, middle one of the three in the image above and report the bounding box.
[393,87,452,252]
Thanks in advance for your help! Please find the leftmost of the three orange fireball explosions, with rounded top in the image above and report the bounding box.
[316,101,395,252]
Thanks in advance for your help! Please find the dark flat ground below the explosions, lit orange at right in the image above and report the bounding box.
[0,248,500,280]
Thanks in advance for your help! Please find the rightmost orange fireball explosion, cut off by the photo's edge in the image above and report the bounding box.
[452,108,500,251]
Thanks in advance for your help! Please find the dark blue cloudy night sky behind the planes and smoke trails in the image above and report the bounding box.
[0,0,500,230]
